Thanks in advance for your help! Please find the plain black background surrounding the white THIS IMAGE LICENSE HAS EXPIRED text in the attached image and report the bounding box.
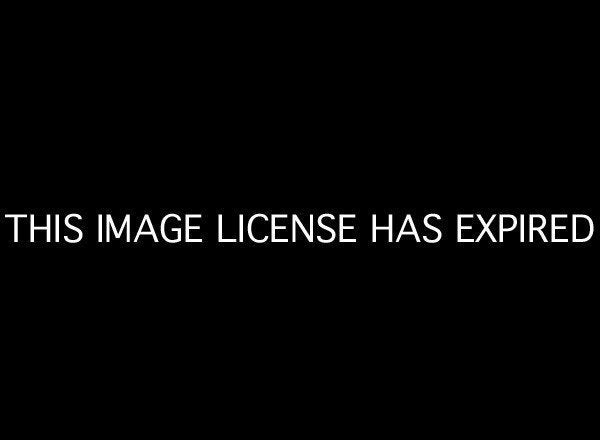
[1,5,598,433]
